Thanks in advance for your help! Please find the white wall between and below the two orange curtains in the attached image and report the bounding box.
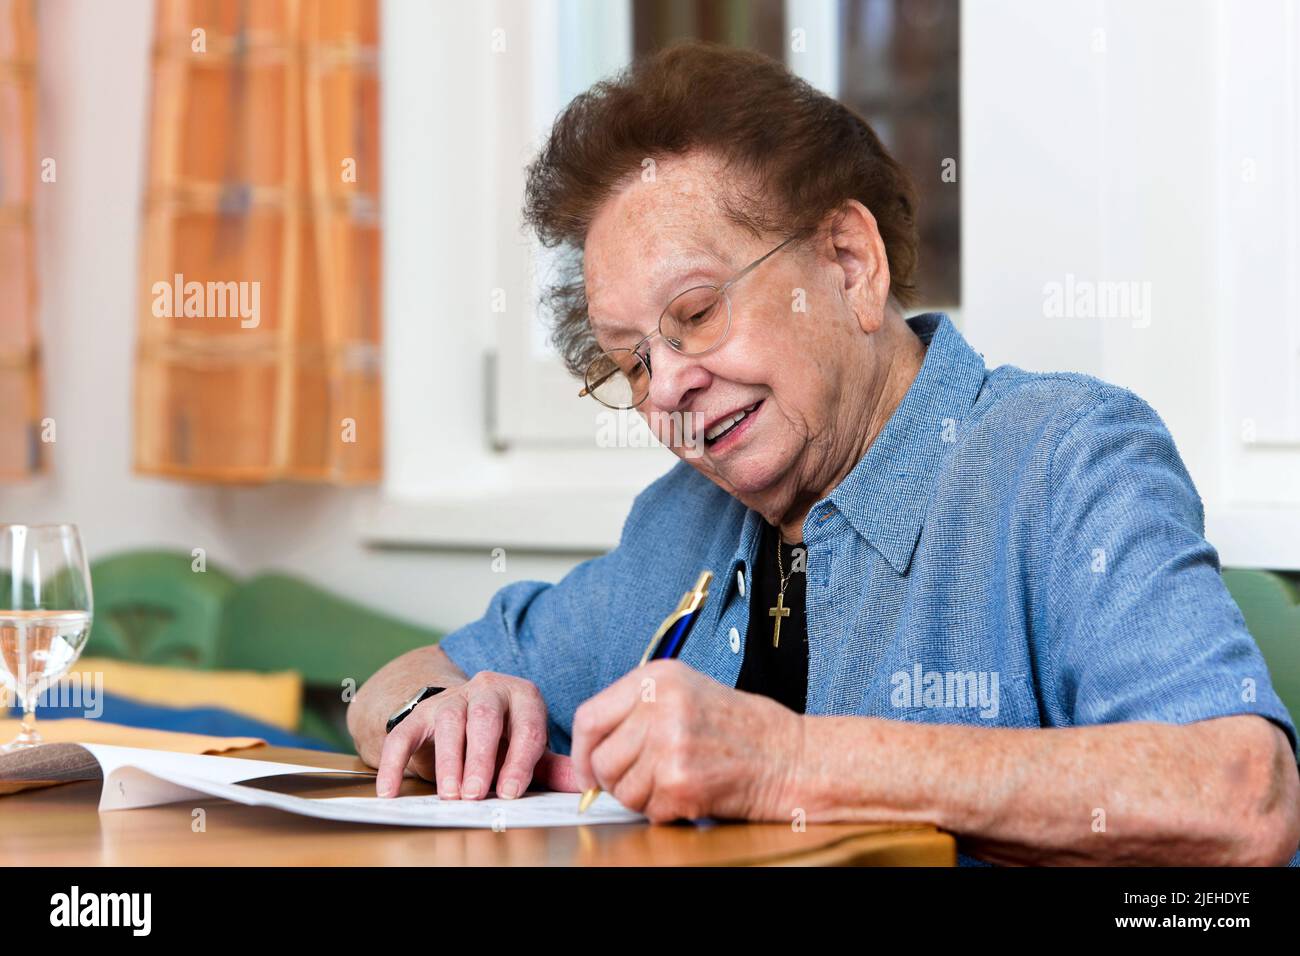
[0,0,590,639]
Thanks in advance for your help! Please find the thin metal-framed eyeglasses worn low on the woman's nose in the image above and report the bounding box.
[577,235,794,408]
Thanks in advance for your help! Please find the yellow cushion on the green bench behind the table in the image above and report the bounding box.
[69,657,303,730]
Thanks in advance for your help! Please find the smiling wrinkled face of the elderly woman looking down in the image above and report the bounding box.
[584,153,888,519]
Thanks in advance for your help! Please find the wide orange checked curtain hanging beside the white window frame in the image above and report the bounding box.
[135,0,382,484]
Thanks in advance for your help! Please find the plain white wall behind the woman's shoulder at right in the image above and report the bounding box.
[961,0,1300,567]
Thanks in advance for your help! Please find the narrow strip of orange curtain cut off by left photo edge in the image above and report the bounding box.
[0,0,44,481]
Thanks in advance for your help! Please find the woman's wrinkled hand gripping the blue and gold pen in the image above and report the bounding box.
[572,661,803,822]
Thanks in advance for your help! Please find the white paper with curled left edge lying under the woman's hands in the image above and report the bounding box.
[83,744,645,830]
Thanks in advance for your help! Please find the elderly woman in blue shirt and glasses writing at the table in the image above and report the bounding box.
[348,44,1300,864]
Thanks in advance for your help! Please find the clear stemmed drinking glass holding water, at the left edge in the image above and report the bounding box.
[0,524,94,750]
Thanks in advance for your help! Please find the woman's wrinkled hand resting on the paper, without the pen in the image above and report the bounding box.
[376,671,579,800]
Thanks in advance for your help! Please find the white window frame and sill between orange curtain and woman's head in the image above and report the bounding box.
[369,0,675,553]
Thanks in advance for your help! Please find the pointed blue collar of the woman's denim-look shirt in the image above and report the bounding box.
[731,312,985,587]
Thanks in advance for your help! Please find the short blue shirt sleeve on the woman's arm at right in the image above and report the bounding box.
[1045,389,1296,750]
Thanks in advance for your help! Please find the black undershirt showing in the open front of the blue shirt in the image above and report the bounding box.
[736,522,809,714]
